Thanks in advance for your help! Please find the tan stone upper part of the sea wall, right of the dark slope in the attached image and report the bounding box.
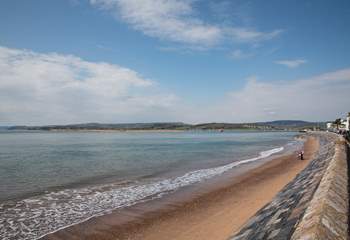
[291,137,349,240]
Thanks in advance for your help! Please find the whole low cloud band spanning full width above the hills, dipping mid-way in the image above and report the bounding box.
[0,47,350,125]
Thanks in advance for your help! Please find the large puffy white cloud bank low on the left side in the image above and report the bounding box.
[0,47,178,124]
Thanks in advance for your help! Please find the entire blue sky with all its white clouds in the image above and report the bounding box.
[0,0,350,125]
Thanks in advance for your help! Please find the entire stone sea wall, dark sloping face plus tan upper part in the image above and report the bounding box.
[229,132,349,240]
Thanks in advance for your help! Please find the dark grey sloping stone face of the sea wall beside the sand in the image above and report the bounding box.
[229,132,339,240]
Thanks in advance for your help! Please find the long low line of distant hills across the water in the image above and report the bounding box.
[9,120,325,130]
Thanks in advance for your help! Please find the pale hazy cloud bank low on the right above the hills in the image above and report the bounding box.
[202,68,350,122]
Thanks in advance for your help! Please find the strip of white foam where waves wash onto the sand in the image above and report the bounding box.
[0,147,284,240]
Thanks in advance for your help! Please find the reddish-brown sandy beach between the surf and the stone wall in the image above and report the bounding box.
[44,137,318,240]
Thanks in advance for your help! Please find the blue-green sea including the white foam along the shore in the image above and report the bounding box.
[0,131,297,239]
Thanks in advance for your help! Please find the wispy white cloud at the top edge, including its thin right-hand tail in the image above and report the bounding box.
[90,0,281,47]
